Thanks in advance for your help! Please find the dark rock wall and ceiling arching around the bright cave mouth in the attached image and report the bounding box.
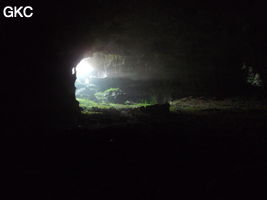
[0,0,267,133]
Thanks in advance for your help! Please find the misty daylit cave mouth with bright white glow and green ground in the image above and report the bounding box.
[72,52,172,110]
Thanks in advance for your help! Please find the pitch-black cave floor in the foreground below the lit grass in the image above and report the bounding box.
[4,98,267,199]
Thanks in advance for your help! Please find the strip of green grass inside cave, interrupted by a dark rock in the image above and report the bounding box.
[77,97,267,115]
